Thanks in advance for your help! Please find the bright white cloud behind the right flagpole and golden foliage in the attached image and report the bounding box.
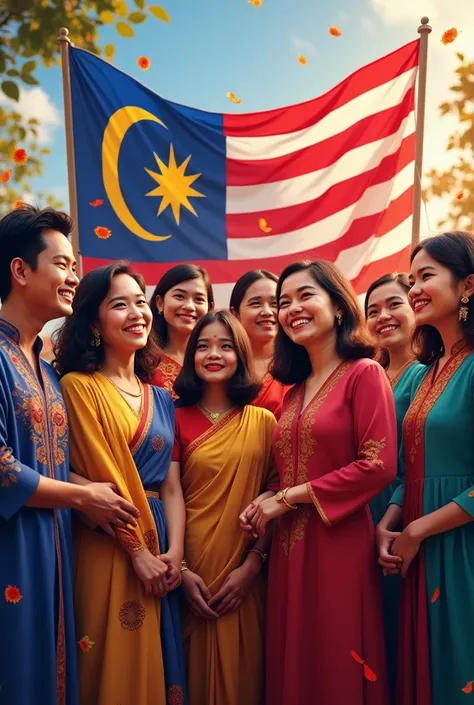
[370,0,474,235]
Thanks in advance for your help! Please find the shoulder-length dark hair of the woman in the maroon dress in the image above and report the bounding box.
[270,260,377,384]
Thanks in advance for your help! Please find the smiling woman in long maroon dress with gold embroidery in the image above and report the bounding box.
[242,262,397,705]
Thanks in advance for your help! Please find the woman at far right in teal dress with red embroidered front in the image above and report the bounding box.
[379,232,474,705]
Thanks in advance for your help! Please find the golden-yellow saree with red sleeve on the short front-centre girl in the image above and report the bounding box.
[176,406,276,705]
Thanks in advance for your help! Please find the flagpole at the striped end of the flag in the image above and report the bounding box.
[411,17,431,247]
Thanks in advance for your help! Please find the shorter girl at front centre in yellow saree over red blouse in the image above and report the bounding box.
[173,311,276,705]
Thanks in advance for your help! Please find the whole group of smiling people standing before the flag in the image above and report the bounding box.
[0,206,474,705]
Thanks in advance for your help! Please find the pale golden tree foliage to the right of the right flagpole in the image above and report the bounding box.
[424,54,474,230]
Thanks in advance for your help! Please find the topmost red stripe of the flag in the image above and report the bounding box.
[223,40,419,137]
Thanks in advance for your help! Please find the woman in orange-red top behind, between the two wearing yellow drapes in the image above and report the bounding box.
[150,264,214,399]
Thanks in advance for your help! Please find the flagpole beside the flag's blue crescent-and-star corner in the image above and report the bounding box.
[58,27,82,277]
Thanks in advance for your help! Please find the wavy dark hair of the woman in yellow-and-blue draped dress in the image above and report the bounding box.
[53,261,160,382]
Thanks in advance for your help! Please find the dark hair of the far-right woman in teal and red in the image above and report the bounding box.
[410,230,474,365]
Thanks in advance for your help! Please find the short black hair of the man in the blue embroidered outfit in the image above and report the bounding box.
[0,203,74,303]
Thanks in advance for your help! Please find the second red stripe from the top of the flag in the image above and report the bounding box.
[226,87,415,186]
